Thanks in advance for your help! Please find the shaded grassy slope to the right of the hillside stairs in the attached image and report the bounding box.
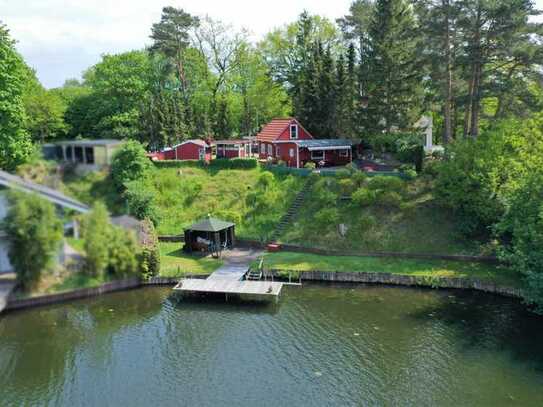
[281,179,491,255]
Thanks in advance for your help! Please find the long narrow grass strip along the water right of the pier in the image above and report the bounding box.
[258,252,521,287]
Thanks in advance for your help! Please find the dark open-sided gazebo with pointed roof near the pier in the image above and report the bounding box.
[184,216,235,253]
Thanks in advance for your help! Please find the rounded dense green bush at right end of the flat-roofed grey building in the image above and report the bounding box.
[111,141,151,189]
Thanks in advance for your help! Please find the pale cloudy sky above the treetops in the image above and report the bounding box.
[0,0,543,87]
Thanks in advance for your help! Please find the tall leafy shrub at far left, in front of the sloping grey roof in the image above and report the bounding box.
[4,193,63,289]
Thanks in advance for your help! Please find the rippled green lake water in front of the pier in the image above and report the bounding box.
[0,285,543,407]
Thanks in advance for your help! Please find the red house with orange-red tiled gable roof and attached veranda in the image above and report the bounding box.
[256,118,353,168]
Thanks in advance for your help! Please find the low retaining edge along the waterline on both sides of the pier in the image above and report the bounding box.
[4,269,522,312]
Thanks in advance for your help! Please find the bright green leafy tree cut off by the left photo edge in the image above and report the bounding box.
[0,24,32,170]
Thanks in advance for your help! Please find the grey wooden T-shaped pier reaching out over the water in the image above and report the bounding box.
[174,249,284,299]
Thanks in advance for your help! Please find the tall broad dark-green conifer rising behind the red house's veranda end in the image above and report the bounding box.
[361,0,423,133]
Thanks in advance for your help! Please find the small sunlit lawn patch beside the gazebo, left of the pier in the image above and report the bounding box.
[159,242,223,277]
